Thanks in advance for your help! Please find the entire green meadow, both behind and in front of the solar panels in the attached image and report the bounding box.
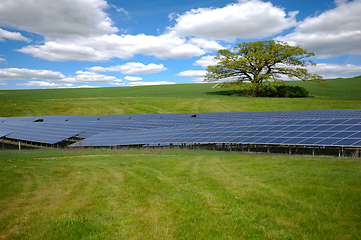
[0,78,361,240]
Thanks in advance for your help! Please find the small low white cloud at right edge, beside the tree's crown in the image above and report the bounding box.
[307,63,361,78]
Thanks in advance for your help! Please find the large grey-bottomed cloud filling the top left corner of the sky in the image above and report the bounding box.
[0,0,118,39]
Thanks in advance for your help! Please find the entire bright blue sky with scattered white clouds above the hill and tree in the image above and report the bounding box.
[0,0,361,90]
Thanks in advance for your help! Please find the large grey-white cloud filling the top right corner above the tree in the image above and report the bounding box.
[276,0,361,58]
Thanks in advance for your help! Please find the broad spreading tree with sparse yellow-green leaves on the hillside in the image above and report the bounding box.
[204,40,324,96]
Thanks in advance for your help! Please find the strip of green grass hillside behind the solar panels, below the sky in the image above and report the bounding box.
[0,78,361,117]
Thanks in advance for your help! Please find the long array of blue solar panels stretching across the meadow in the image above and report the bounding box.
[0,110,361,147]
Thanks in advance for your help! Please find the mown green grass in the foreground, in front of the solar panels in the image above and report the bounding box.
[0,149,361,239]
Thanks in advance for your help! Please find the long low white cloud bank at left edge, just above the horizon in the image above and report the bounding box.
[0,68,118,87]
